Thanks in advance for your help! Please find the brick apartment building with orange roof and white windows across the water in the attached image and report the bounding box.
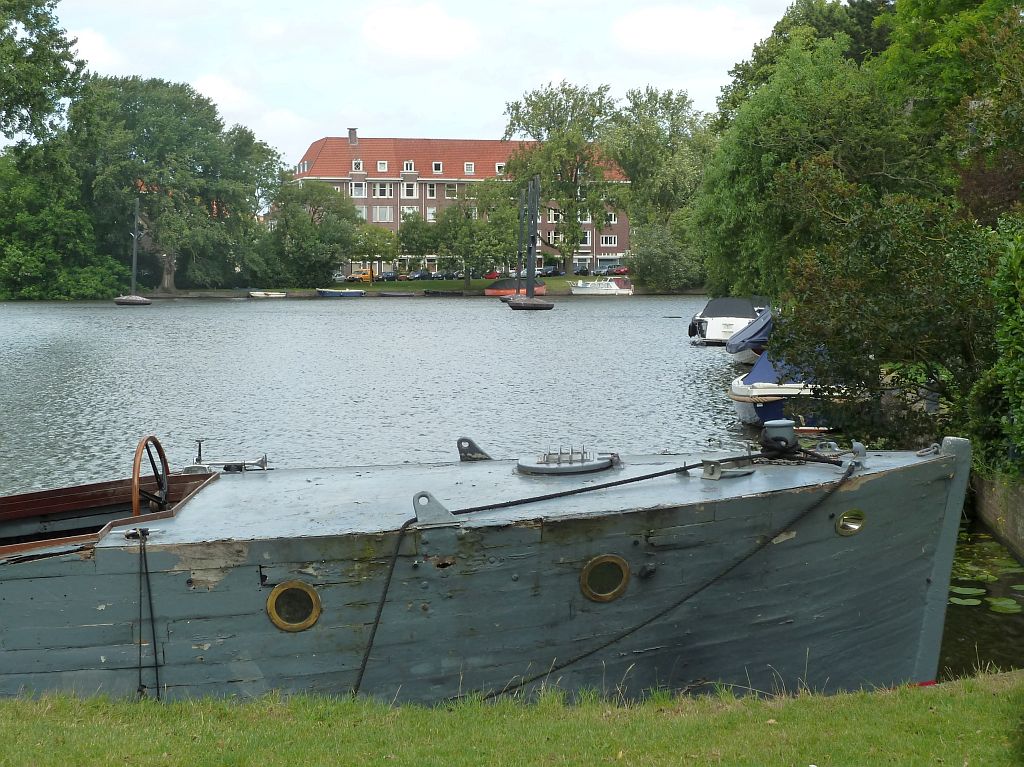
[294,128,630,268]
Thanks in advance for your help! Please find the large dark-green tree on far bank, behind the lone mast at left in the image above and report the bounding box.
[68,77,280,291]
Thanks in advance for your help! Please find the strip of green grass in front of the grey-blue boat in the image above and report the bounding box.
[0,672,1024,767]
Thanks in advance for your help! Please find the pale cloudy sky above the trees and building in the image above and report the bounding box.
[56,0,792,165]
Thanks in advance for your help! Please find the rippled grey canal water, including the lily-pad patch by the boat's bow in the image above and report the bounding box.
[0,296,1024,676]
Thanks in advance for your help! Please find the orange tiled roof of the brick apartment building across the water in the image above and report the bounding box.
[295,136,623,181]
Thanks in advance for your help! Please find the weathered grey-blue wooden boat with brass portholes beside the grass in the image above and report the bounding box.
[0,422,970,702]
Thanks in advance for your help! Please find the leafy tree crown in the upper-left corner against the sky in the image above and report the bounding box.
[0,0,85,139]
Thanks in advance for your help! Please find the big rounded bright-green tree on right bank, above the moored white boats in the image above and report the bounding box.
[694,36,929,297]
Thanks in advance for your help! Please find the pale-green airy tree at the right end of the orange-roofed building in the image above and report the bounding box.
[601,87,717,226]
